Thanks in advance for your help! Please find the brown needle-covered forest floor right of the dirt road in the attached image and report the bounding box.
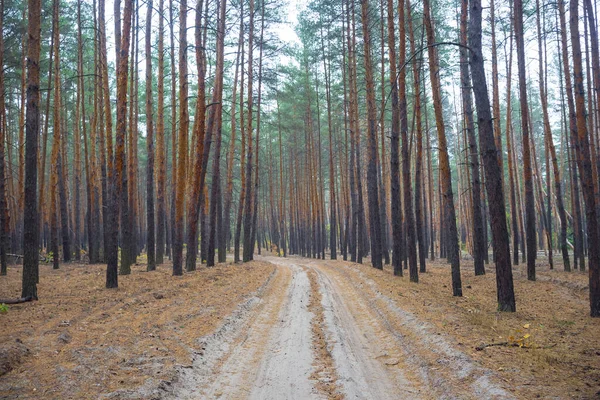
[349,261,600,399]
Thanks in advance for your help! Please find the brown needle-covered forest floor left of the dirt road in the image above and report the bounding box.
[0,262,274,399]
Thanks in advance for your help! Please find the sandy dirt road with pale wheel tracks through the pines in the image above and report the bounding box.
[169,257,512,399]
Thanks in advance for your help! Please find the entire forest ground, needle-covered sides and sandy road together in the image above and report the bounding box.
[0,252,600,399]
